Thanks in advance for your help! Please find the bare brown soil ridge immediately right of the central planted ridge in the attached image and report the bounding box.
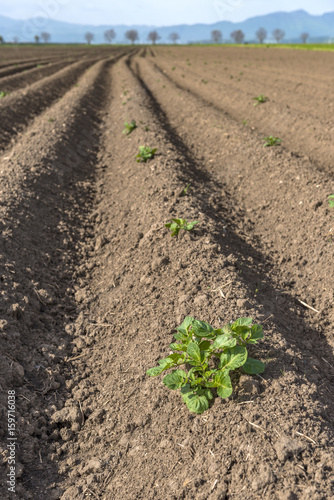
[136,54,334,346]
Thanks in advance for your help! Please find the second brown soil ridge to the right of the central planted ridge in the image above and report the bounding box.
[154,48,334,174]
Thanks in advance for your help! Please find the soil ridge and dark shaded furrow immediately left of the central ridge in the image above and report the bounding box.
[0,48,130,500]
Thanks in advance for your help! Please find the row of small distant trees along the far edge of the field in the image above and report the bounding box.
[0,28,309,45]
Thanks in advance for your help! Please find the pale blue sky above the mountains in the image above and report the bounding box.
[0,0,334,26]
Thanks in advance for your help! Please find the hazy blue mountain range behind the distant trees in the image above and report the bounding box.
[0,10,334,43]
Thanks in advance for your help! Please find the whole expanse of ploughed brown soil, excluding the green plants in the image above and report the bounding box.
[0,48,334,500]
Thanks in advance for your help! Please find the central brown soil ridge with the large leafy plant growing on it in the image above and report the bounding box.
[46,51,334,500]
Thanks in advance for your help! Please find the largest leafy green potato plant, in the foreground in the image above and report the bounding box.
[146,316,265,413]
